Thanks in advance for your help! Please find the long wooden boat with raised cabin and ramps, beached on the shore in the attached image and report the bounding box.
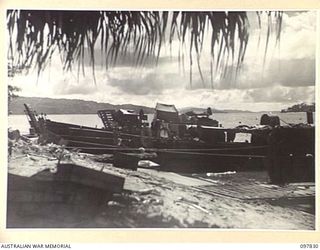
[25,103,270,172]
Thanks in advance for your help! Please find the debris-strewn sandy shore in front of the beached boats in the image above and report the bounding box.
[7,132,315,230]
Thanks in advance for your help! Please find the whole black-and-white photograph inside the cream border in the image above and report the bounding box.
[3,8,317,231]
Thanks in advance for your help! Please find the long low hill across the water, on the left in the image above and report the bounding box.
[9,97,154,115]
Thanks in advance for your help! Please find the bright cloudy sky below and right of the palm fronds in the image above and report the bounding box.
[8,11,317,111]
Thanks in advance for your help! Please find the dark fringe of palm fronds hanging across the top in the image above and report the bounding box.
[7,10,282,85]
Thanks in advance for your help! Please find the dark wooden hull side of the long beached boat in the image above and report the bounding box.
[36,118,268,172]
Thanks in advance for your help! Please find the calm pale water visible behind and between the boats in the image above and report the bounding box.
[8,112,307,134]
